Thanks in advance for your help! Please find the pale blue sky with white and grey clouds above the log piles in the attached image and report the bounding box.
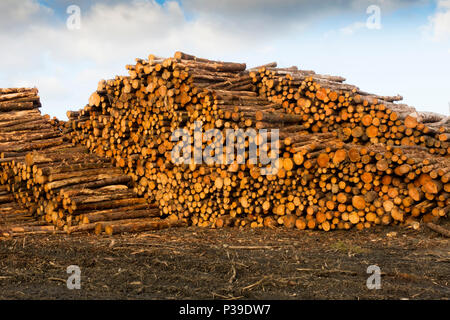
[0,0,450,119]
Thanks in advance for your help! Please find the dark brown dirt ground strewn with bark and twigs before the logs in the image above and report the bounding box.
[0,221,450,299]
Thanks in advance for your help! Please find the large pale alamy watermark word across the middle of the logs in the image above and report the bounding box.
[170,121,279,175]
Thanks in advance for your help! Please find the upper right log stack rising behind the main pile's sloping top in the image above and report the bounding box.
[249,67,450,156]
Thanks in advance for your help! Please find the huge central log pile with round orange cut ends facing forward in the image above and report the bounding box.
[65,52,450,231]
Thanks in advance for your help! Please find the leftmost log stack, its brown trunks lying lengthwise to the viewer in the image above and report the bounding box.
[0,89,177,235]
